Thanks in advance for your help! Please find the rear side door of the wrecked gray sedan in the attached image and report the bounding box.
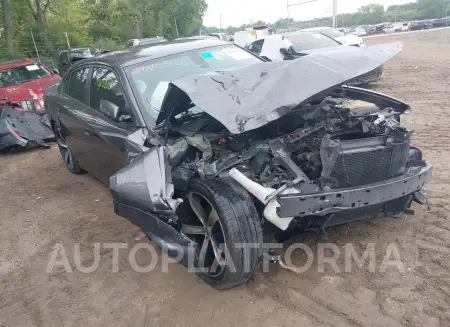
[56,65,90,165]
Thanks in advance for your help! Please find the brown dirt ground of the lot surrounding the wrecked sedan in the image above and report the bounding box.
[0,30,450,327]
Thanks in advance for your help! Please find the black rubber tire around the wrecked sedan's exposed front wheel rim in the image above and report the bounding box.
[183,179,263,290]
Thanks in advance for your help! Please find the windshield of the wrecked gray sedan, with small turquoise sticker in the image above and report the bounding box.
[126,45,261,121]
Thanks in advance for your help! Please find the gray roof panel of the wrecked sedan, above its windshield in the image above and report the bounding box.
[88,38,231,67]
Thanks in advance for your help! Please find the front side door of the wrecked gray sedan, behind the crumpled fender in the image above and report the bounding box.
[77,65,132,184]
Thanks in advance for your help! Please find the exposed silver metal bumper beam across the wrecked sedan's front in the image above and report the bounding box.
[277,166,433,218]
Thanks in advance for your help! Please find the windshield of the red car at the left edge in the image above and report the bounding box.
[0,63,51,87]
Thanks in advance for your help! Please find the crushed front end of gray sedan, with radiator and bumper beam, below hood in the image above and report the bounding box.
[169,87,432,230]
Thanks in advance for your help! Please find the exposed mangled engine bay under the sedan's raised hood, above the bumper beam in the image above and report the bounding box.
[157,88,409,196]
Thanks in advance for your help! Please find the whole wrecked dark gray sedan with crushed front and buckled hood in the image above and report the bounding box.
[45,40,432,289]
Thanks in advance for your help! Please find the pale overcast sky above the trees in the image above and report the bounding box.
[203,0,414,28]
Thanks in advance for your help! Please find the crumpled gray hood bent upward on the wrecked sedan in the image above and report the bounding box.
[158,43,402,134]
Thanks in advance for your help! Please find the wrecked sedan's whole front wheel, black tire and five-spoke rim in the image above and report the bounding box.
[182,180,263,289]
